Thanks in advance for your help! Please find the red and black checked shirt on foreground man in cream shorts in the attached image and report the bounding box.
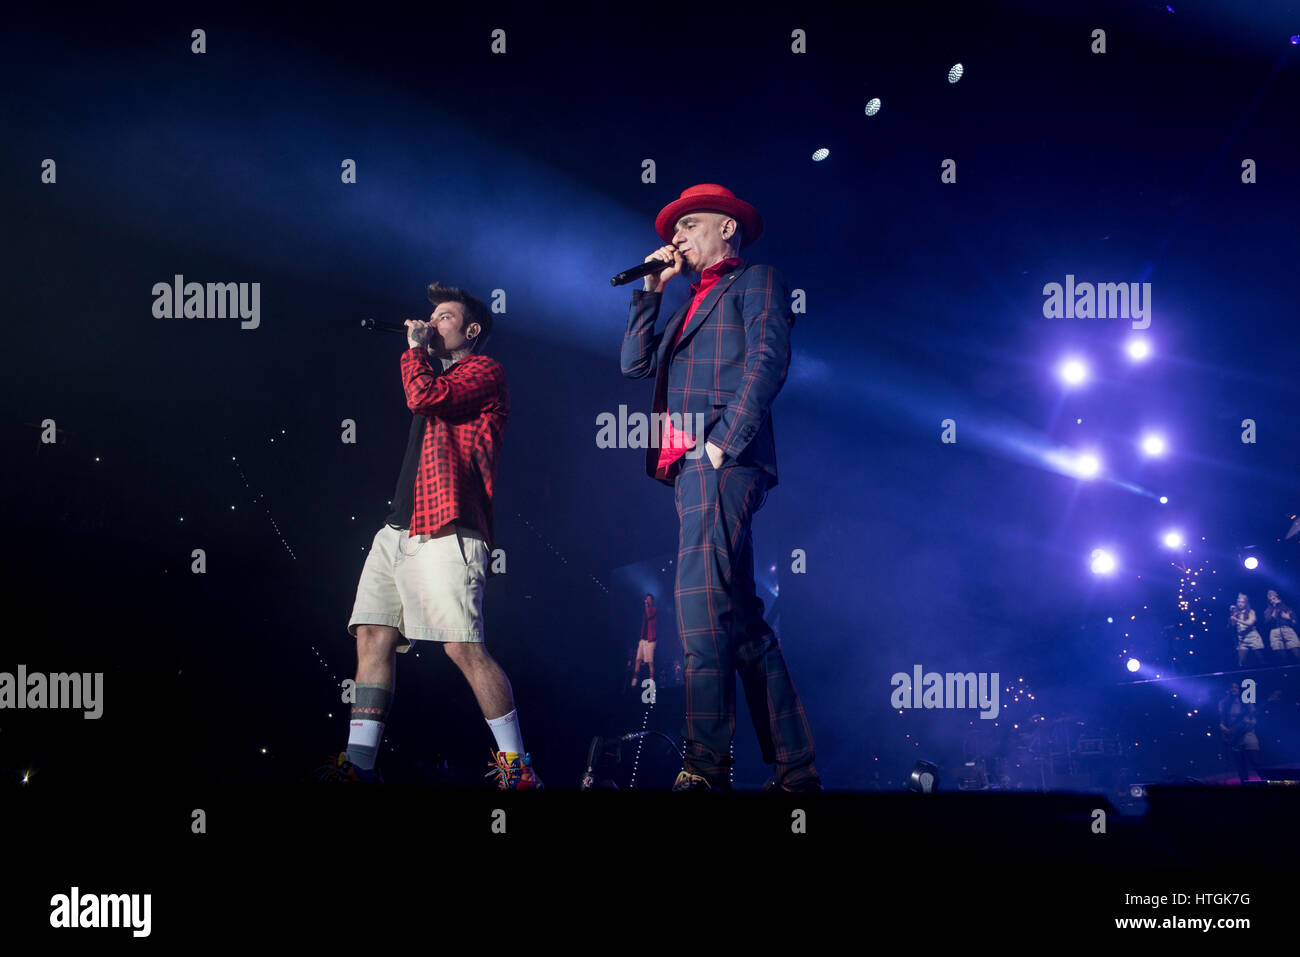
[402,346,510,549]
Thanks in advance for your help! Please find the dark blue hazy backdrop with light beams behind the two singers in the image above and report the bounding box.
[0,3,1300,789]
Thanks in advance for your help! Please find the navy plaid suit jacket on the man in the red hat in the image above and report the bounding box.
[620,264,794,488]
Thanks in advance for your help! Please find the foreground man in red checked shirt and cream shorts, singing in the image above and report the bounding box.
[324,282,542,789]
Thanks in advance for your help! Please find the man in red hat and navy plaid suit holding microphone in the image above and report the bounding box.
[621,183,822,792]
